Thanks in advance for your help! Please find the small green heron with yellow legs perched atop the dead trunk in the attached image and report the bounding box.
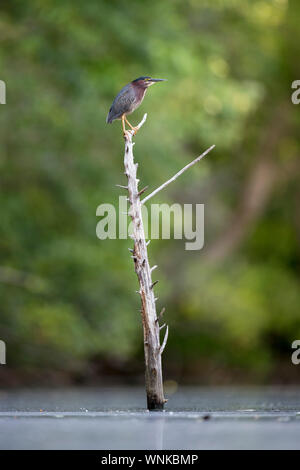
[106,77,165,135]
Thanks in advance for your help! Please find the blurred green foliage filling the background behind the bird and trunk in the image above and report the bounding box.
[0,0,300,381]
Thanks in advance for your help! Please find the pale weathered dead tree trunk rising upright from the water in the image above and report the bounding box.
[124,122,166,410]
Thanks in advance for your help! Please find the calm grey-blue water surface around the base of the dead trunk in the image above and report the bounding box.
[0,387,300,449]
